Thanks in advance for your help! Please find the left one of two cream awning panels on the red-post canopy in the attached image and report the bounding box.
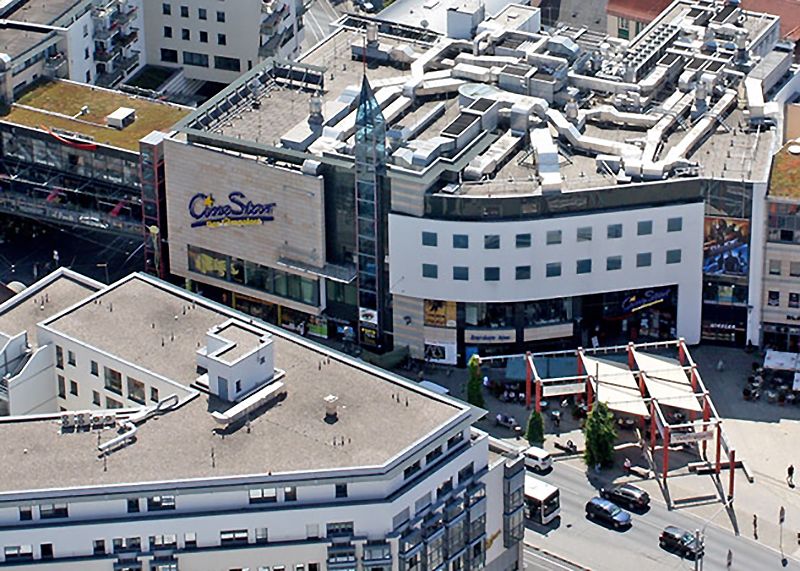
[581,354,650,417]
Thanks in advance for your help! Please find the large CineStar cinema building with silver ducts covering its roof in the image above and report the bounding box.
[165,0,798,364]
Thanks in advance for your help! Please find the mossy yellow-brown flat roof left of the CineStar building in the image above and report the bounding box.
[5,81,191,151]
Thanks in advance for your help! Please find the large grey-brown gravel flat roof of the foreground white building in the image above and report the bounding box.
[0,275,468,492]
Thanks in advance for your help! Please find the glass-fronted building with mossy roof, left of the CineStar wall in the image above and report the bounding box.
[0,80,189,275]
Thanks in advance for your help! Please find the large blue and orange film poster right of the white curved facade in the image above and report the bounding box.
[703,216,750,276]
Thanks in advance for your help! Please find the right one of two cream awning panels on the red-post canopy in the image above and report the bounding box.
[633,350,703,412]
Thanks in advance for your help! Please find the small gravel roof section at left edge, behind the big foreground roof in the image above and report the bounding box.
[0,272,99,346]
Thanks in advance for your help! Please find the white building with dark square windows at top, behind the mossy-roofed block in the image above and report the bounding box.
[144,0,304,83]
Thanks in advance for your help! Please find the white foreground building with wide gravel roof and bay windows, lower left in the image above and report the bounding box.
[0,271,525,571]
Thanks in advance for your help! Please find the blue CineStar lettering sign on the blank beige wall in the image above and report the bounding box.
[189,190,275,228]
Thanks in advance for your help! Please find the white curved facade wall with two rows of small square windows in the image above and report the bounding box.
[389,202,703,343]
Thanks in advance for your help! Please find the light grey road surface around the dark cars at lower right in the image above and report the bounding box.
[525,460,800,571]
